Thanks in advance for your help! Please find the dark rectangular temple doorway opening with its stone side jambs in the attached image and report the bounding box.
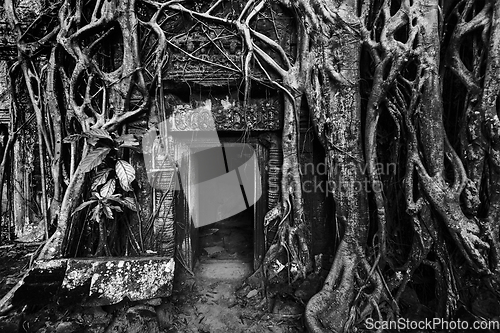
[176,137,268,275]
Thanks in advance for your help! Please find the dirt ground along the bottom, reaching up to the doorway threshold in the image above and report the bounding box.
[0,239,319,333]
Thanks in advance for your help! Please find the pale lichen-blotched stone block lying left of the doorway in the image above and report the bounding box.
[62,257,175,306]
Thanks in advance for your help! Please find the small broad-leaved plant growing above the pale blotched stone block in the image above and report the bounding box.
[64,129,139,256]
